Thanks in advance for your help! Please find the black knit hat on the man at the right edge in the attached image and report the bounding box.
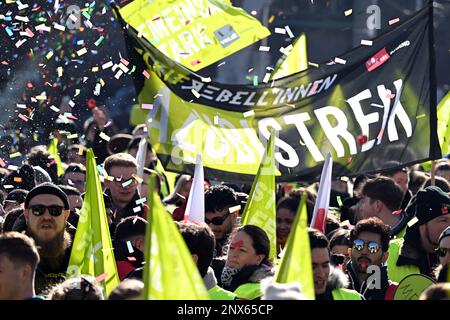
[416,186,450,225]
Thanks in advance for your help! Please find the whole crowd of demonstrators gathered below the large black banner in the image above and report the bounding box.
[0,104,450,300]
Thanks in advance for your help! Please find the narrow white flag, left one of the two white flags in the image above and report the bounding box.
[184,154,205,222]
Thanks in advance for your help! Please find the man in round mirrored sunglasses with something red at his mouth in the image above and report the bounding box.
[347,217,398,300]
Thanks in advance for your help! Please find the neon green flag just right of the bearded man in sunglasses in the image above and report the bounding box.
[67,148,119,296]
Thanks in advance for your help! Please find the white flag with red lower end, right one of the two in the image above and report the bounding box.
[310,152,333,233]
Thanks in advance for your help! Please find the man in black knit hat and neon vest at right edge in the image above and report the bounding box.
[387,186,450,282]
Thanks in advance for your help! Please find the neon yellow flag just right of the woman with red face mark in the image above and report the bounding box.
[275,193,315,300]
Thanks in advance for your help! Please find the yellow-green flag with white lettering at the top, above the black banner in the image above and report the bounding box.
[119,0,270,71]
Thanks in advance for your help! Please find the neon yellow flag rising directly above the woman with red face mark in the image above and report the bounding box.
[241,130,277,259]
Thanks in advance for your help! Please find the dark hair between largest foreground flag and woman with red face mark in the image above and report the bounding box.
[176,221,216,277]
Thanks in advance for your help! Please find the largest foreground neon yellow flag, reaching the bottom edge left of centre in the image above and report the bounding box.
[143,174,209,300]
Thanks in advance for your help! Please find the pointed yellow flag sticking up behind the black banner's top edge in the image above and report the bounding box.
[270,33,308,80]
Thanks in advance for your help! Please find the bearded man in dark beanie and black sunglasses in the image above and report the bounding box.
[23,182,72,294]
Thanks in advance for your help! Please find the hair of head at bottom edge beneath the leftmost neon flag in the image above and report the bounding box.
[48,275,103,300]
